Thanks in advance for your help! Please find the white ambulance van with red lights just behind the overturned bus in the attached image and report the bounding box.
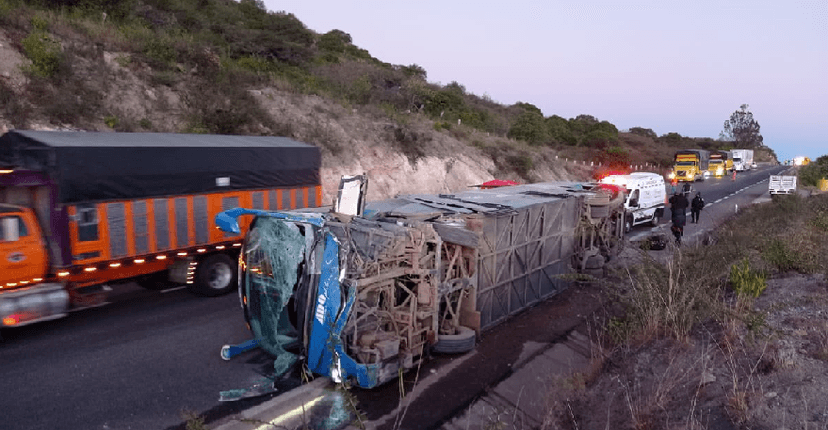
[601,172,667,232]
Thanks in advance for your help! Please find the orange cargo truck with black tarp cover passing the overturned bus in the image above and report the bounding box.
[0,130,322,328]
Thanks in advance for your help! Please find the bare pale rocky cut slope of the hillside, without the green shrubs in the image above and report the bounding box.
[0,29,590,207]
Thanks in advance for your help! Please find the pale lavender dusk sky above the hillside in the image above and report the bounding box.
[265,0,828,160]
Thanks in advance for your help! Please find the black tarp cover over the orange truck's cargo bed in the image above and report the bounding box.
[0,130,321,203]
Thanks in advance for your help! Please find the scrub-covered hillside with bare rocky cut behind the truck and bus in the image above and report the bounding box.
[0,0,772,202]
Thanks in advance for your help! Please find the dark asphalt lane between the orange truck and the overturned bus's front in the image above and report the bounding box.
[0,284,294,430]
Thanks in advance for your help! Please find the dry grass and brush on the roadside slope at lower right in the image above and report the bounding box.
[543,195,828,429]
